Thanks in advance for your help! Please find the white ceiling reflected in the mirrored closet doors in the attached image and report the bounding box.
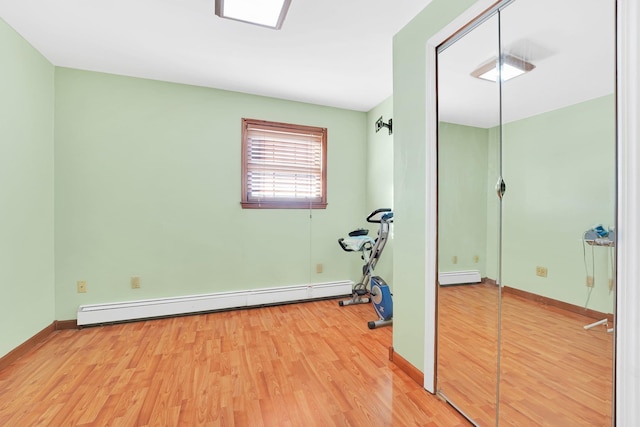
[438,0,615,128]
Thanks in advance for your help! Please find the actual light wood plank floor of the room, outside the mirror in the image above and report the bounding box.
[0,300,468,427]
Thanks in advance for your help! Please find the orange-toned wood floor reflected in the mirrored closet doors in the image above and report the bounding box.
[437,285,613,426]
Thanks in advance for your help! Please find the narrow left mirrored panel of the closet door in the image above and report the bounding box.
[437,11,500,425]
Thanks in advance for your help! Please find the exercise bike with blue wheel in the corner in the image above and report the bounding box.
[338,209,393,329]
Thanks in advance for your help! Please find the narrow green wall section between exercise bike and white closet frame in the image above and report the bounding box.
[393,0,474,374]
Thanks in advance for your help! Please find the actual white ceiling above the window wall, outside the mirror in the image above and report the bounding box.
[0,0,431,111]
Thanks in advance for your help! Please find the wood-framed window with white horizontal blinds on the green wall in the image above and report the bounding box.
[241,119,327,209]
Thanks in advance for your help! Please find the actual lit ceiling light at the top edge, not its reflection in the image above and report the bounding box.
[216,0,291,30]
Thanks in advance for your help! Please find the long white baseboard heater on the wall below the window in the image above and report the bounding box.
[78,280,353,326]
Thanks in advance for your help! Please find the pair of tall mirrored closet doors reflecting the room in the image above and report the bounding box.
[437,0,616,426]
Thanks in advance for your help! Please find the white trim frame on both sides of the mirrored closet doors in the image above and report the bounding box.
[423,0,640,425]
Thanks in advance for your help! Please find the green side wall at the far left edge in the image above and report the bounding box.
[0,20,55,357]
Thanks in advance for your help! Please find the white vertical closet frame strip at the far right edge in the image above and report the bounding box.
[615,0,640,426]
